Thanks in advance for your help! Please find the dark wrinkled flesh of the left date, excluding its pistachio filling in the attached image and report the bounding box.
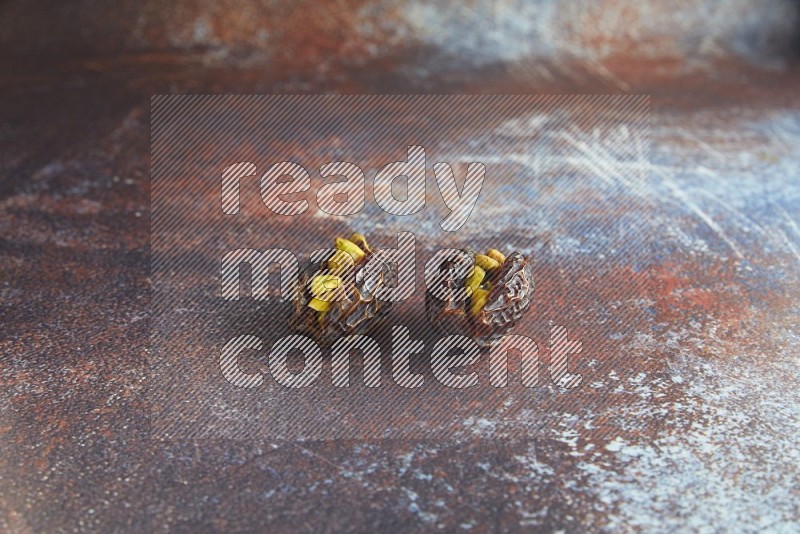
[289,261,397,347]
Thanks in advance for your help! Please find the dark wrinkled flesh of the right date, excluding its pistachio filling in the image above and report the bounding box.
[425,251,535,348]
